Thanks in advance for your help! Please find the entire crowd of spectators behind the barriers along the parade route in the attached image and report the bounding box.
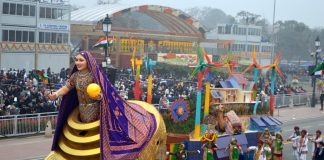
[0,64,305,116]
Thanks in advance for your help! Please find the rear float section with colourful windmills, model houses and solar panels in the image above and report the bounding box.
[167,50,282,160]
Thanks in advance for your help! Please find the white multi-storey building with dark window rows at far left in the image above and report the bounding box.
[0,0,71,72]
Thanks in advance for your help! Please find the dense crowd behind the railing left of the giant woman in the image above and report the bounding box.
[0,68,68,116]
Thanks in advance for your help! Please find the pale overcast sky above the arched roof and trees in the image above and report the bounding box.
[70,0,324,28]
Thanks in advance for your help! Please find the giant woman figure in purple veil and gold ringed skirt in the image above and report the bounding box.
[46,52,166,160]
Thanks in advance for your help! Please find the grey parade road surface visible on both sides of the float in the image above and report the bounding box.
[0,107,324,160]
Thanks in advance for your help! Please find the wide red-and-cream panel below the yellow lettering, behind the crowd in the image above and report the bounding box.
[157,53,213,67]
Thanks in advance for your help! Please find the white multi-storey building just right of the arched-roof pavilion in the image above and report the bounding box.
[201,24,274,65]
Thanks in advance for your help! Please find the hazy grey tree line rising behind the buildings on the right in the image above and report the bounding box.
[186,7,324,60]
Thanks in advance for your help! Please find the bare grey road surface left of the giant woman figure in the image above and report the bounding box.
[0,135,52,160]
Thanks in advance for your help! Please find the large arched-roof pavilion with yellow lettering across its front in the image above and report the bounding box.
[71,4,205,68]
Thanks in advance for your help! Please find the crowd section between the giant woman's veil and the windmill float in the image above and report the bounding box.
[115,69,197,104]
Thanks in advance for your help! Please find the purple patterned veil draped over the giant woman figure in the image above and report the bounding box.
[52,52,156,160]
